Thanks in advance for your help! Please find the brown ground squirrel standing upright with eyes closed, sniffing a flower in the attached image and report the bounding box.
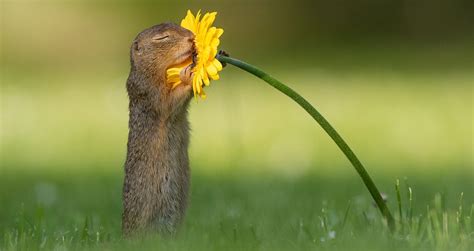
[122,23,195,236]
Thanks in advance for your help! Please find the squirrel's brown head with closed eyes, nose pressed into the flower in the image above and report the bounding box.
[127,23,194,114]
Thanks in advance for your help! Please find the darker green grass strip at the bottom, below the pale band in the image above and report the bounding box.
[0,166,474,250]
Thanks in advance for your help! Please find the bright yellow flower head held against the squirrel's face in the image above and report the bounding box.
[166,10,224,98]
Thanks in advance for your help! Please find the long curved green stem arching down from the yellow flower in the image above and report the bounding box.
[217,55,395,230]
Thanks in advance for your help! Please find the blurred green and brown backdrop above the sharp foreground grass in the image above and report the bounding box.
[0,0,474,249]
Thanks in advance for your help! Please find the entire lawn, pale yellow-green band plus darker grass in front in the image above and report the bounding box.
[0,65,474,250]
